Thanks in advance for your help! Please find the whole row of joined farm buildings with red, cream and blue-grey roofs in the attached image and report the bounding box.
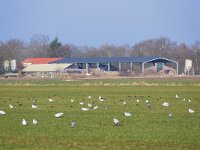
[22,56,178,75]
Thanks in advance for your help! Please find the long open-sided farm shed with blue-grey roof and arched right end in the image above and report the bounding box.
[50,56,178,74]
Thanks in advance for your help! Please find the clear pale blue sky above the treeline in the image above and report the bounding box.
[0,0,200,47]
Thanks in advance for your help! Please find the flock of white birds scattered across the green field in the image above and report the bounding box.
[0,94,195,127]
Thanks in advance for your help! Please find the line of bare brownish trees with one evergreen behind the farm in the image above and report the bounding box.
[0,35,200,74]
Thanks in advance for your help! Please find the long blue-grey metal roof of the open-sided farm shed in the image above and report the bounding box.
[50,56,176,63]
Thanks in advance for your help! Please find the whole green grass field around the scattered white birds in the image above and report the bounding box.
[0,79,200,150]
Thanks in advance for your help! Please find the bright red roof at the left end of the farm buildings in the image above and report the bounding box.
[21,58,63,64]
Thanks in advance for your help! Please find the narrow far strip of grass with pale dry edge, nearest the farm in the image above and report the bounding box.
[0,77,200,86]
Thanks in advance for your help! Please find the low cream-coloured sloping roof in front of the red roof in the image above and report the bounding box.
[22,64,72,72]
